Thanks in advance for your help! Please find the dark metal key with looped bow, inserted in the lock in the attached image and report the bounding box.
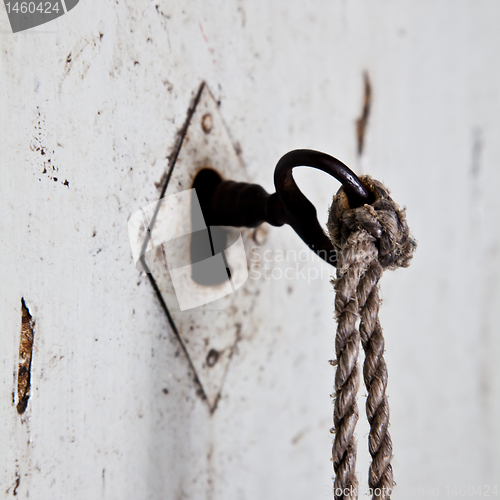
[199,149,371,266]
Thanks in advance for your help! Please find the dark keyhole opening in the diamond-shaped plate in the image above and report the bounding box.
[190,168,231,286]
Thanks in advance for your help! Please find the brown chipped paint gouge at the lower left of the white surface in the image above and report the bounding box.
[17,299,35,415]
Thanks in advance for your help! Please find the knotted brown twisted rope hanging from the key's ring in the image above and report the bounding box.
[328,176,416,500]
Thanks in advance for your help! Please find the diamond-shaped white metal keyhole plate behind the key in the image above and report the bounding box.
[138,85,265,410]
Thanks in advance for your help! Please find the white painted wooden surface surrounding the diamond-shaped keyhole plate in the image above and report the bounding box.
[0,0,500,500]
